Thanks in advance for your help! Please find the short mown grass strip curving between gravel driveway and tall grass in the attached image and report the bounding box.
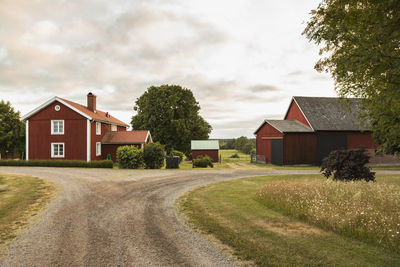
[177,175,400,266]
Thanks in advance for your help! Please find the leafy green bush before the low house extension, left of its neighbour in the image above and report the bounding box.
[117,146,144,169]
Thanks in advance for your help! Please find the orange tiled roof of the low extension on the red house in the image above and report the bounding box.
[101,131,152,145]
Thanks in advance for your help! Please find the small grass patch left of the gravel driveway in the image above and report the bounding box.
[0,173,55,244]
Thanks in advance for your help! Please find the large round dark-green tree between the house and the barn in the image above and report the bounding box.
[131,85,212,154]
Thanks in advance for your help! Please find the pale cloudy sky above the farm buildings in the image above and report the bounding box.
[0,0,335,138]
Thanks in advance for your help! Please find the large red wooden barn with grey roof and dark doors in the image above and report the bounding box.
[254,96,399,165]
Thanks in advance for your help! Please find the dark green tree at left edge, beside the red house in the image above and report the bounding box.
[0,100,25,158]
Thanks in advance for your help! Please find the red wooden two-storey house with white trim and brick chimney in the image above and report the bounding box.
[22,93,152,161]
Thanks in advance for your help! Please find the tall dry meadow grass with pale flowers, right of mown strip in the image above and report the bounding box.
[257,180,400,251]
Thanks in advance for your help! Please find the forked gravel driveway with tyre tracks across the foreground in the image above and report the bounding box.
[0,167,324,266]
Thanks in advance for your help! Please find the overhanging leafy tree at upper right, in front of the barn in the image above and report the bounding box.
[303,0,400,154]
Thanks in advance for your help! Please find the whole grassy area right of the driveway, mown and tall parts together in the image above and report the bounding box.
[177,175,400,266]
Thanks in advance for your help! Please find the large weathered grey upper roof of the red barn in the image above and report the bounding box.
[285,96,368,131]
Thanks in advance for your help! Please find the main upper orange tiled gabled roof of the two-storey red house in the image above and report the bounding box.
[21,96,129,127]
